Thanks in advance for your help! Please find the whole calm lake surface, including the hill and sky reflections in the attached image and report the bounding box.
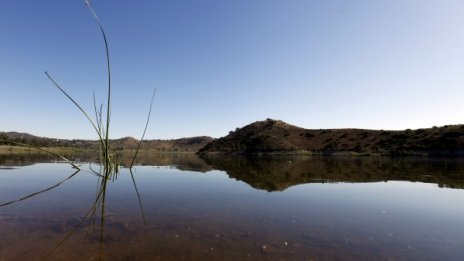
[0,154,464,261]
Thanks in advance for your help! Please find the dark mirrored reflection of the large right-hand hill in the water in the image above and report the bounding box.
[199,153,464,191]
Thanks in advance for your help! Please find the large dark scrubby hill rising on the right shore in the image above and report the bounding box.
[199,119,464,156]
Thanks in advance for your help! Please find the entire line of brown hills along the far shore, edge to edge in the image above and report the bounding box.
[0,119,464,156]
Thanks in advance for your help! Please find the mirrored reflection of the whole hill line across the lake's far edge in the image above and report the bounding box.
[0,152,464,191]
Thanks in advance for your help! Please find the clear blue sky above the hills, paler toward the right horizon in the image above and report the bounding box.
[0,0,464,139]
